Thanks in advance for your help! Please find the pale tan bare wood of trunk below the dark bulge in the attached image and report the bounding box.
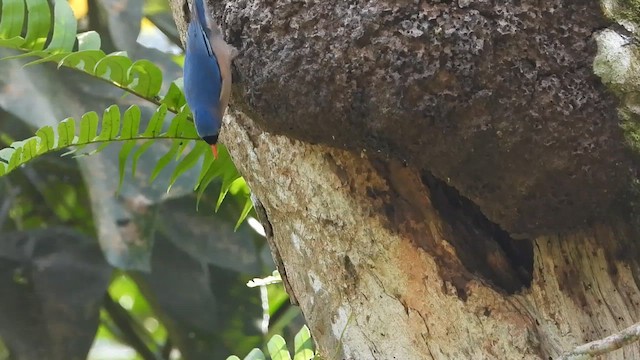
[223,113,640,359]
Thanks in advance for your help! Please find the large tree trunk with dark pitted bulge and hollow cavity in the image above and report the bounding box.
[173,0,640,359]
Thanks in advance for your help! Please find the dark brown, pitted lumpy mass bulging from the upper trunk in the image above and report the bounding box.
[217,0,635,237]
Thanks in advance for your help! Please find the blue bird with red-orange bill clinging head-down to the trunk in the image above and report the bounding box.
[184,0,237,159]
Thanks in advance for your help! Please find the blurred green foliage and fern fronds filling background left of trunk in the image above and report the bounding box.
[0,0,309,359]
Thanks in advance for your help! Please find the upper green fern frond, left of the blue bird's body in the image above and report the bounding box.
[0,0,186,114]
